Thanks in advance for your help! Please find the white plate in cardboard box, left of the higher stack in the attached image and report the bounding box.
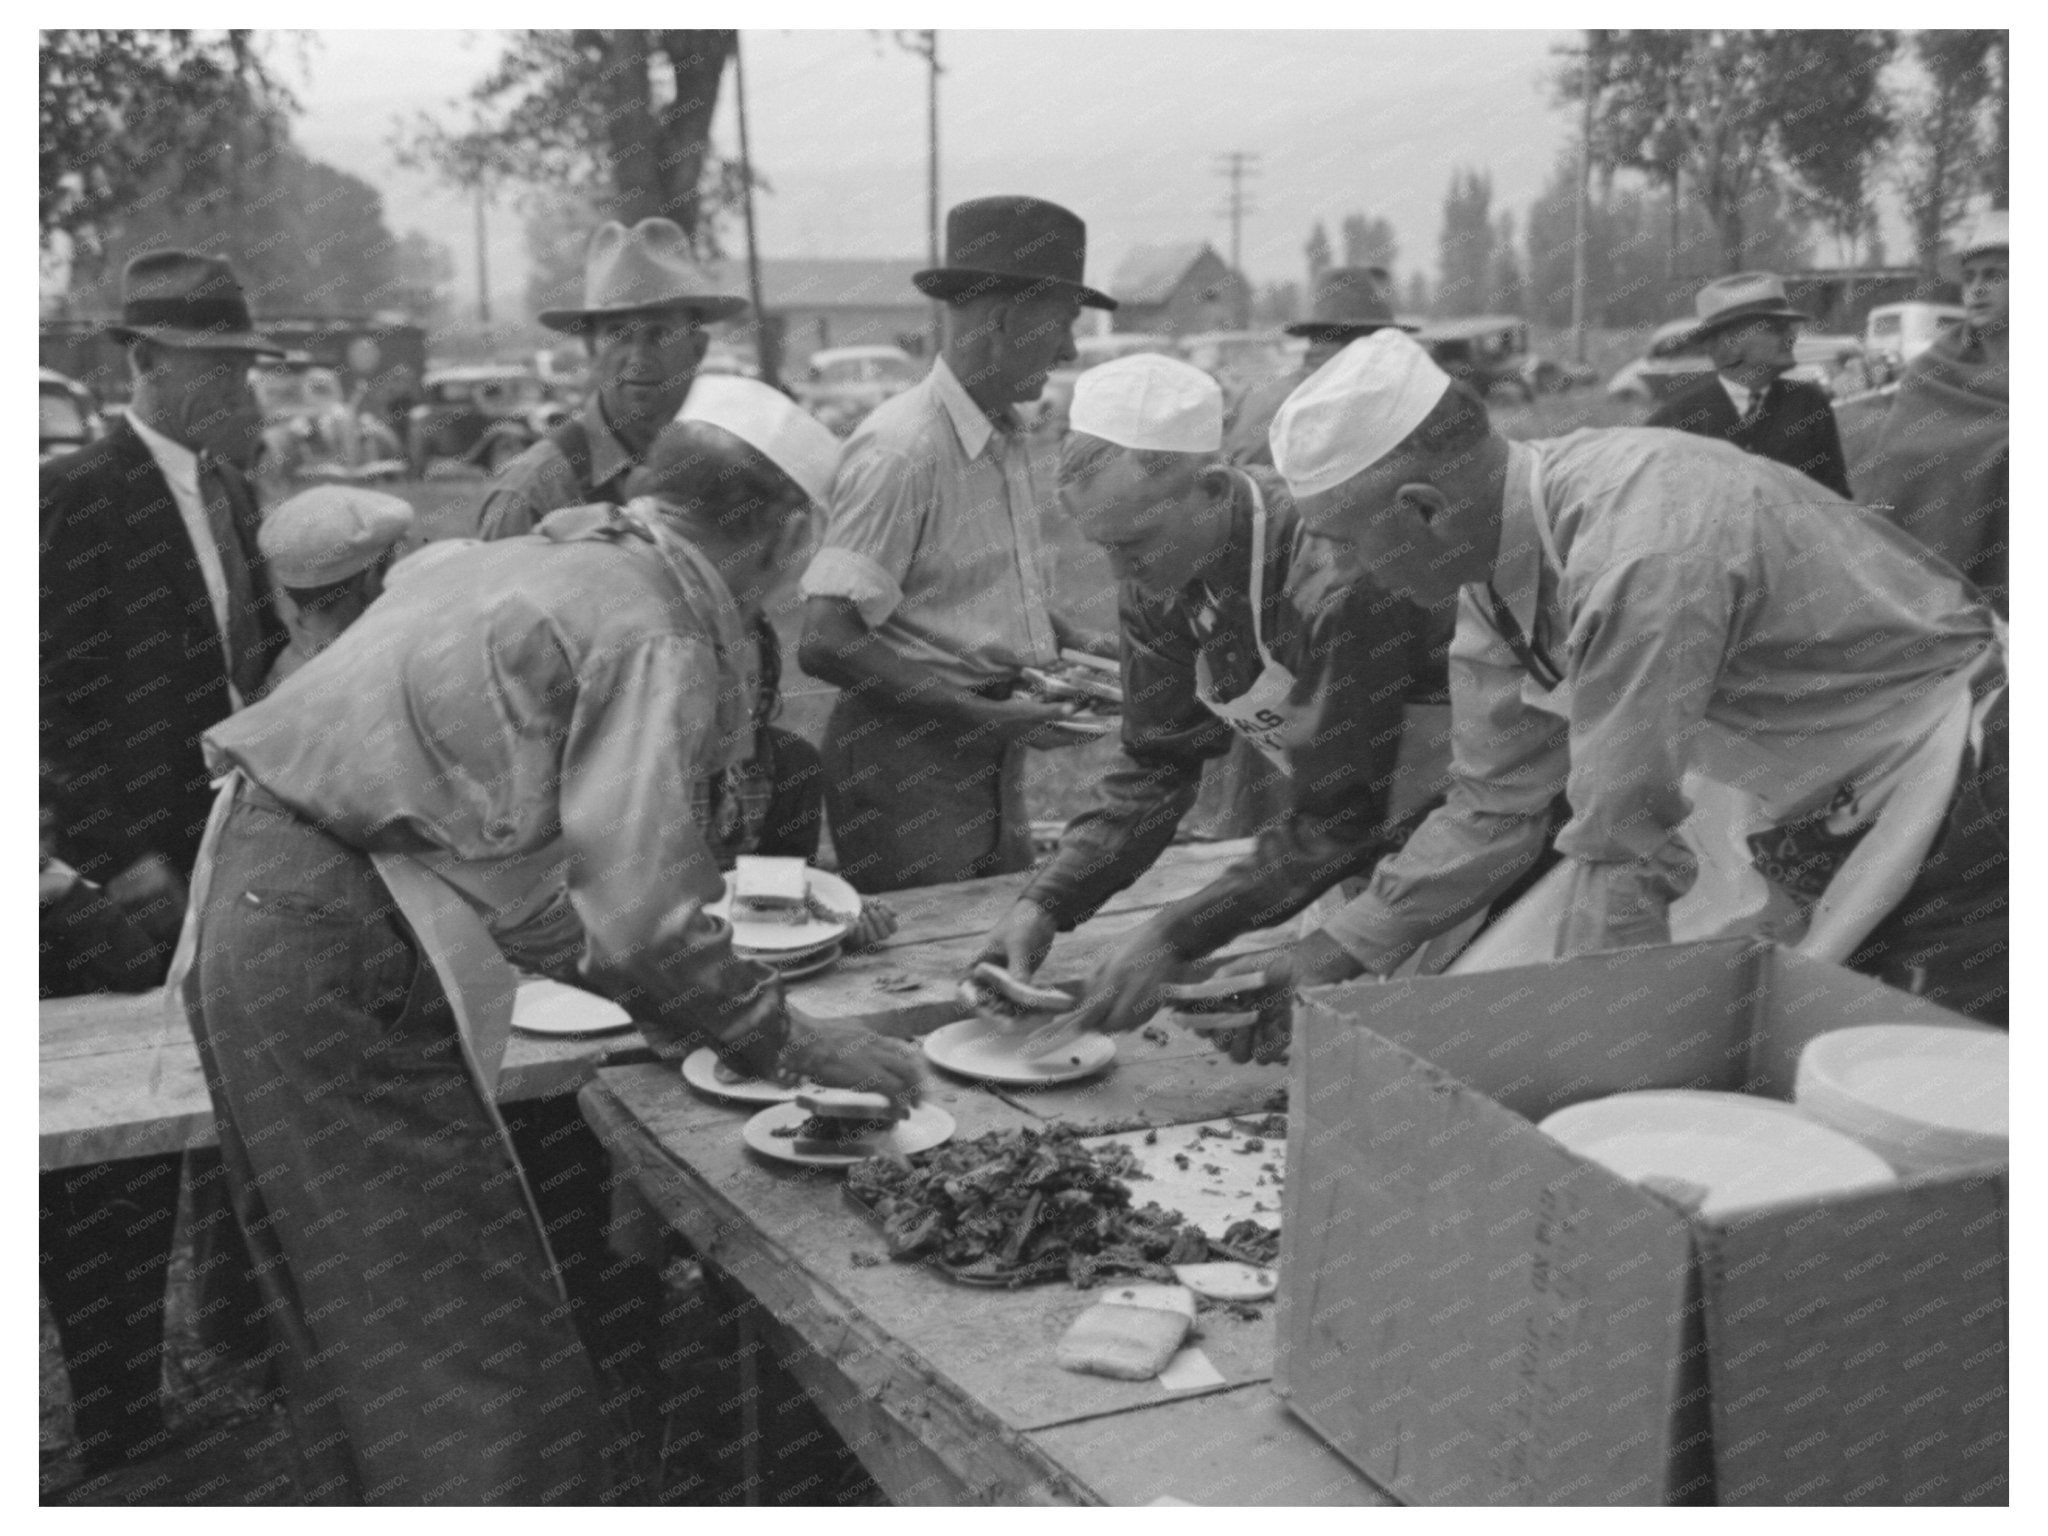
[1536,1090,1892,1217]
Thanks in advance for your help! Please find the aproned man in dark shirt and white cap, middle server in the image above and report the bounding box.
[983,354,1444,1030]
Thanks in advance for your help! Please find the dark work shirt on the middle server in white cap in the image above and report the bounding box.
[1024,469,1444,956]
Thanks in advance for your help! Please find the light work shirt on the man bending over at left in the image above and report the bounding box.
[205,506,784,1073]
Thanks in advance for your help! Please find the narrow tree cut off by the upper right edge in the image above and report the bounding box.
[1894,31,2005,287]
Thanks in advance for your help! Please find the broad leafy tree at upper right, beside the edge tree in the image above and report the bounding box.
[1556,31,1884,272]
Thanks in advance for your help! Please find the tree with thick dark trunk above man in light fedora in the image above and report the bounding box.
[397,29,739,256]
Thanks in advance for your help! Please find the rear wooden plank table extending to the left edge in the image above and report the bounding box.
[37,842,1245,1171]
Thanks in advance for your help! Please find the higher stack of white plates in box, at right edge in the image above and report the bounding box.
[1792,1024,2009,1174]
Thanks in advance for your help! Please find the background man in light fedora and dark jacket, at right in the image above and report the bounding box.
[1645,272,1849,496]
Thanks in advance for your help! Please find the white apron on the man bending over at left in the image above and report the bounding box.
[164,782,567,1300]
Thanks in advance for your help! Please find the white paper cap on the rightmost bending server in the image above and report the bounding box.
[1266,330,1450,496]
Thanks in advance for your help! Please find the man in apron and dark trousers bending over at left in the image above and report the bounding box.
[172,454,920,1503]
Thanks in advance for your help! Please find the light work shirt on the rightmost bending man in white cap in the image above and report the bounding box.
[1327,428,1997,973]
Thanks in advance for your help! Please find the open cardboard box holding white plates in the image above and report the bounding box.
[1276,940,2007,1503]
